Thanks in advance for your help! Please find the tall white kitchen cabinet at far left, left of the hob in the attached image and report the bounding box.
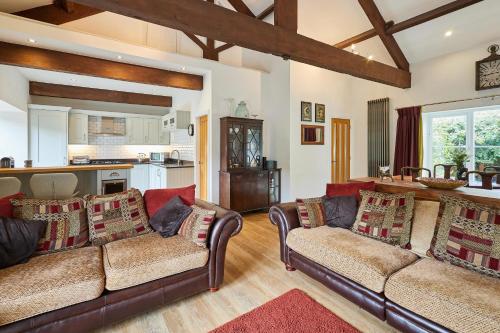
[29,107,69,167]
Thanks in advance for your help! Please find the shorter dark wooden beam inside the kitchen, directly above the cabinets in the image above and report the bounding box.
[30,81,172,107]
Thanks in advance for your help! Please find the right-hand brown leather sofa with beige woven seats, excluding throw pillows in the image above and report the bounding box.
[269,201,500,333]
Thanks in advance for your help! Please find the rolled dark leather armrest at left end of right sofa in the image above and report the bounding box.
[269,202,300,268]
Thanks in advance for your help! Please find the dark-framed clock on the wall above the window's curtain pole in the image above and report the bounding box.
[476,44,500,90]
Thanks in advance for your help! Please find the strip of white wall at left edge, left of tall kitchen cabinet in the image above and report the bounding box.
[0,66,29,166]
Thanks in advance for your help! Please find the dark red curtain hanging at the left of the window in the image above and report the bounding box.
[394,106,422,175]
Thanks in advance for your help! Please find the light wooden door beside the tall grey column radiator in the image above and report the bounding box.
[332,118,351,183]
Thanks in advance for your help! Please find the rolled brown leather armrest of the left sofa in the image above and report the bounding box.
[195,199,243,290]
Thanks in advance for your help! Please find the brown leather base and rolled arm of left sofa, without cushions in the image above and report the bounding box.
[0,200,243,333]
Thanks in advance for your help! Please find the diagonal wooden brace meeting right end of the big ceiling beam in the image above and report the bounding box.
[358,0,410,71]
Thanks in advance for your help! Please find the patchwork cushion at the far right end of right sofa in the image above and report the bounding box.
[430,195,500,278]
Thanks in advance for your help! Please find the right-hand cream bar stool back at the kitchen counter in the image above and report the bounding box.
[30,173,78,200]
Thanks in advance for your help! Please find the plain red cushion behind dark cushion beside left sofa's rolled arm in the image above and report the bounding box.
[144,185,196,218]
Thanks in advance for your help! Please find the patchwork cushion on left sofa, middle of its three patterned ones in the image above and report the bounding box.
[85,188,152,245]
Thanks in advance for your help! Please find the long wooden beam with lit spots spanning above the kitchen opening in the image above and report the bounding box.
[0,42,203,90]
